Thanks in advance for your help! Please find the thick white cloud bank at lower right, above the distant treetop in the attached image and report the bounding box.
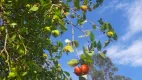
[108,39,142,66]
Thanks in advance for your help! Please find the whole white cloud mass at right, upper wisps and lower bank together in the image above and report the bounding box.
[101,0,142,66]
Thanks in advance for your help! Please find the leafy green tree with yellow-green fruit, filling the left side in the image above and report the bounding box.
[0,0,131,80]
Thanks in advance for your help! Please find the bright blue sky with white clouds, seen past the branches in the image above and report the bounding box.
[59,0,142,80]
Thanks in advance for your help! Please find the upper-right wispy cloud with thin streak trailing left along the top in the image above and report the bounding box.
[101,0,142,40]
